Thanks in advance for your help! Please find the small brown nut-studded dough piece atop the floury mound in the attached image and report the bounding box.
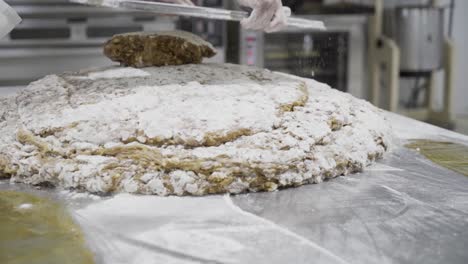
[104,31,216,68]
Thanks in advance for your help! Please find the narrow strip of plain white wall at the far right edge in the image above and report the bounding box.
[453,0,468,115]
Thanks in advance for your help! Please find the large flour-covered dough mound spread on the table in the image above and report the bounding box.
[0,64,390,195]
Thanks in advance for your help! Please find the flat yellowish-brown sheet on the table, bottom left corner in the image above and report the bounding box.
[0,191,94,264]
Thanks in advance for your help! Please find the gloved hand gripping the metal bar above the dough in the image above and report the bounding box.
[237,0,287,32]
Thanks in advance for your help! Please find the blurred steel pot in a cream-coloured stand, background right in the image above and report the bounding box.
[369,0,455,128]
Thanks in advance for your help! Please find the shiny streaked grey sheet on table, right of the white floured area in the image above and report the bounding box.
[234,149,468,263]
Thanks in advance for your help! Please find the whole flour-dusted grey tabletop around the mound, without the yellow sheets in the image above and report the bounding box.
[0,112,468,264]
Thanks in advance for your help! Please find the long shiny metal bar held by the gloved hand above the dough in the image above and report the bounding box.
[71,0,325,30]
